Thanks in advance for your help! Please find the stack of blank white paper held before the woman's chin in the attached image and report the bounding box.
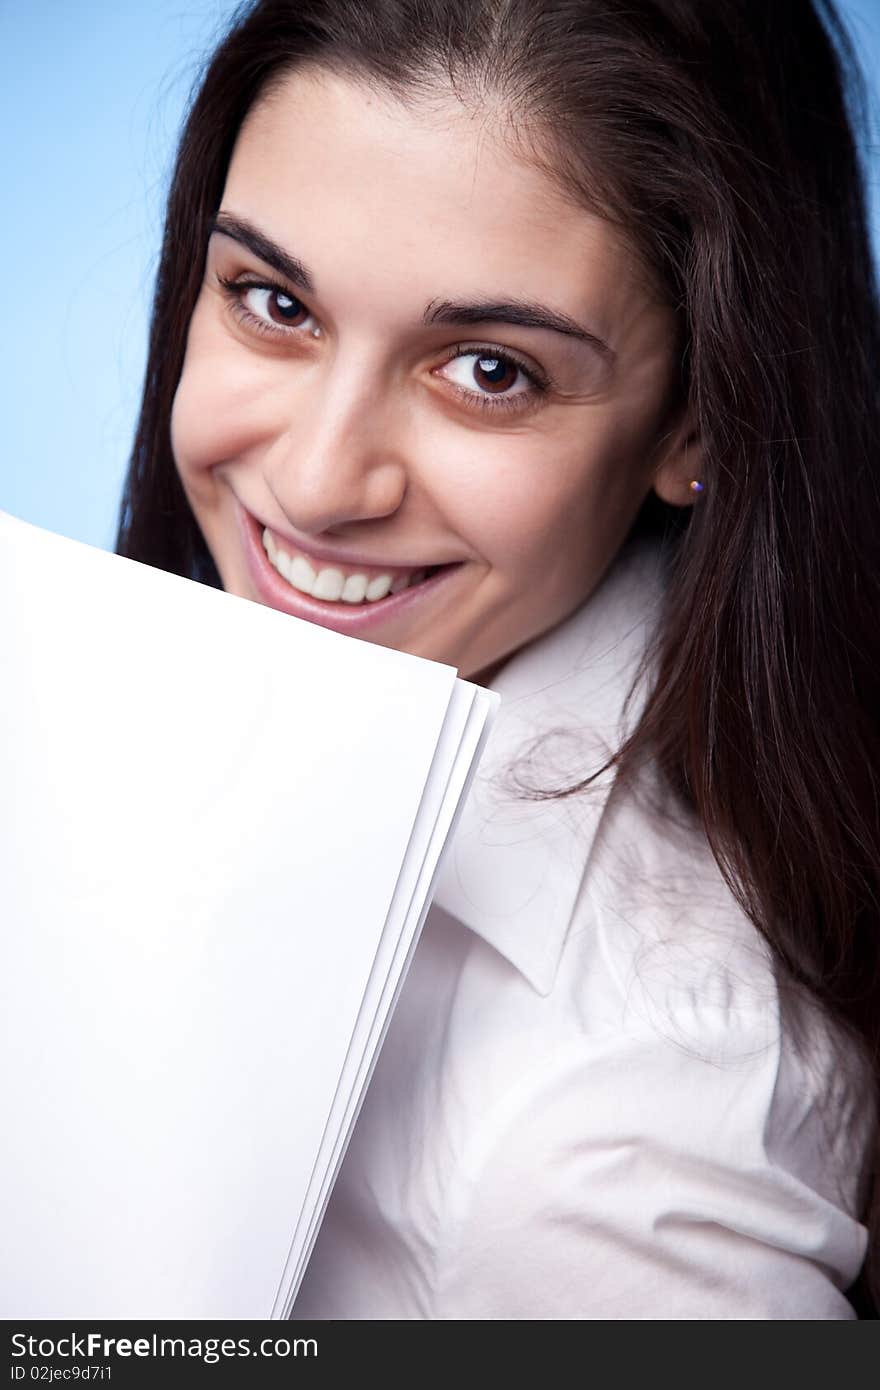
[0,513,499,1319]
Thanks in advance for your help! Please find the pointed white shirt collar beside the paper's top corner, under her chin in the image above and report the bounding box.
[434,539,663,995]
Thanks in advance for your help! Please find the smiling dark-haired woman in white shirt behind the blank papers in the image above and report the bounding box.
[117,0,880,1319]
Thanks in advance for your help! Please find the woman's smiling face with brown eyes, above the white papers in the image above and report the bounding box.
[171,70,690,680]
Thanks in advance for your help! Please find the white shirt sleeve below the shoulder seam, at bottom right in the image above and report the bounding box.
[439,1009,866,1321]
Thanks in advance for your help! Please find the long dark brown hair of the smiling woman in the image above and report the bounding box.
[117,0,880,1316]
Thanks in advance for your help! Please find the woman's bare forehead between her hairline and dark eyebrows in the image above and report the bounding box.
[224,68,661,339]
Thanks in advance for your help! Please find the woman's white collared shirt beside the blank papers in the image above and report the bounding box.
[292,542,873,1319]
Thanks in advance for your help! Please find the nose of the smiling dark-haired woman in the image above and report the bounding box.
[264,361,407,535]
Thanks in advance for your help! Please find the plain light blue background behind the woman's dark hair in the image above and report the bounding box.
[0,0,880,548]
